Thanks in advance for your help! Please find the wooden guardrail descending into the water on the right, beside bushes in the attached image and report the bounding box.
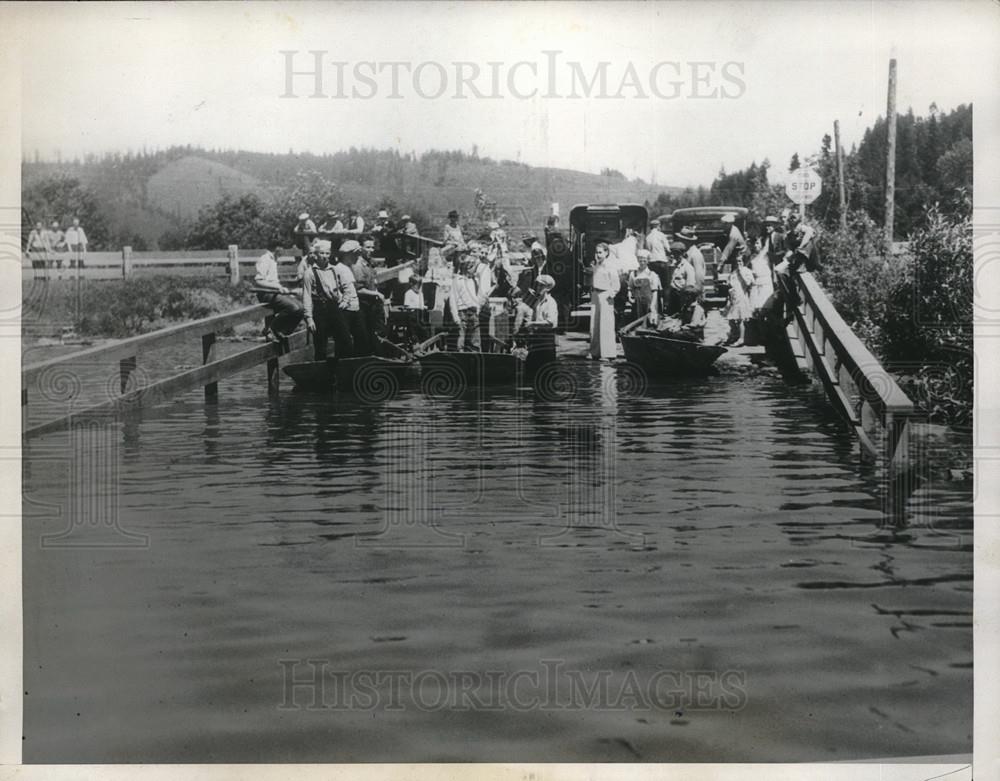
[793,271,923,464]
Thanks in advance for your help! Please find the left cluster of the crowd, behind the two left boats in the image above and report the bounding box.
[254,210,559,360]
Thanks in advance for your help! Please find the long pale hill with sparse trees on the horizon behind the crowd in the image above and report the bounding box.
[22,147,681,249]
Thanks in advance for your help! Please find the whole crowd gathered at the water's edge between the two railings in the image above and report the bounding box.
[255,210,815,360]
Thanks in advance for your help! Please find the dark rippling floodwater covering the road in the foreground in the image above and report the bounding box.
[23,342,972,763]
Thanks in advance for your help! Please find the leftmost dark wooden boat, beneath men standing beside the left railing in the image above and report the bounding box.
[284,340,420,401]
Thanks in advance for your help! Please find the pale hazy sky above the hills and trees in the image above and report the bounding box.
[9,0,1000,186]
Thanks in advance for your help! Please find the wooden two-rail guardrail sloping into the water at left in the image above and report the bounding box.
[21,304,309,437]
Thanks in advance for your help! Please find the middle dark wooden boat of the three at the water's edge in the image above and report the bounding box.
[414,333,524,396]
